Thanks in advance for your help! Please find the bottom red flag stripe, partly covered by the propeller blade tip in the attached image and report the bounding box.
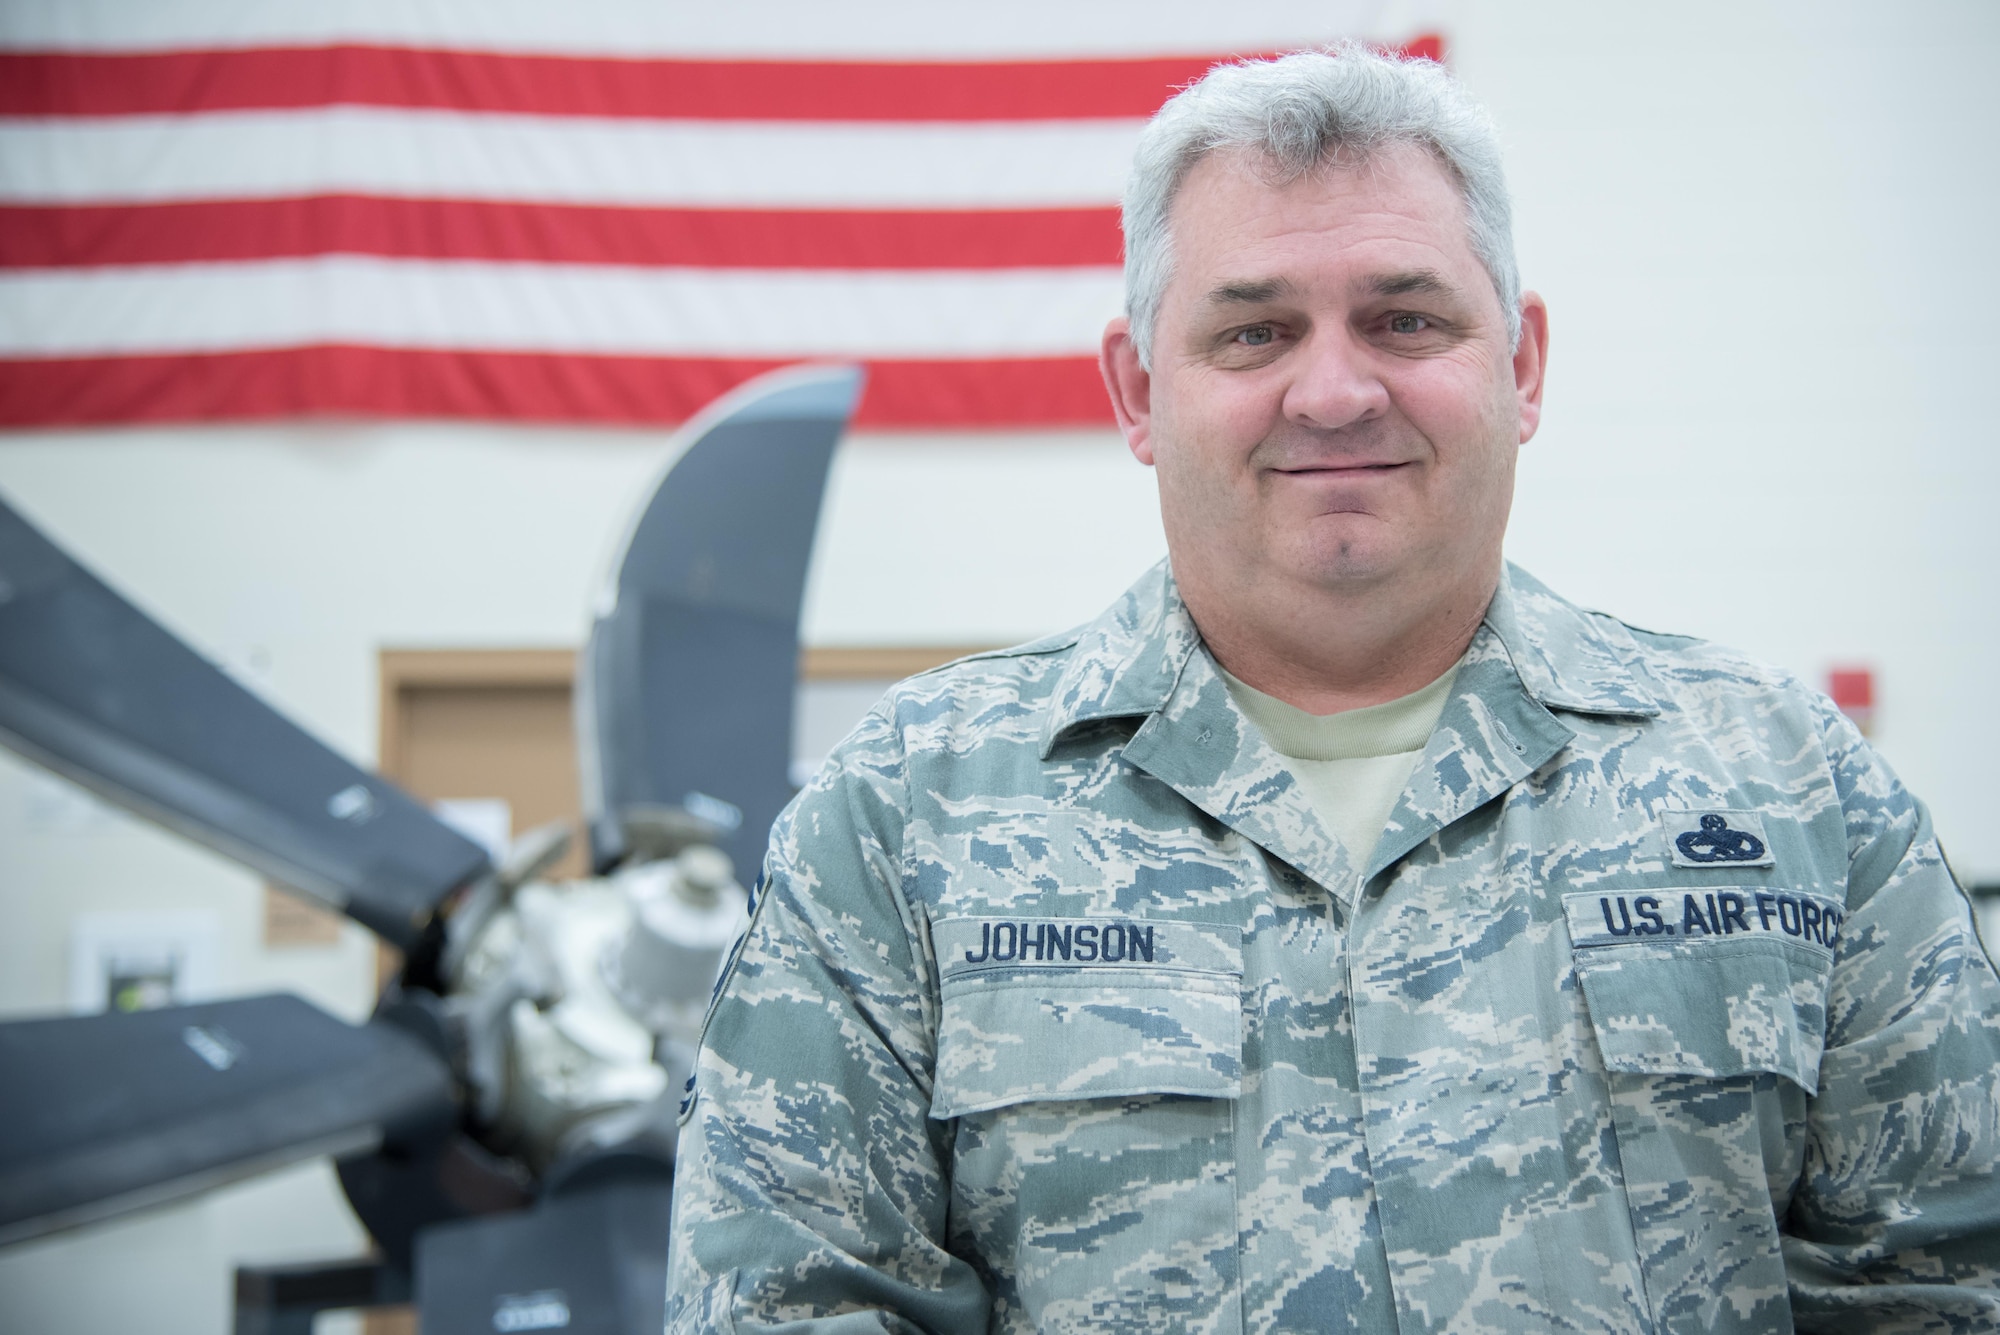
[0,346,1112,428]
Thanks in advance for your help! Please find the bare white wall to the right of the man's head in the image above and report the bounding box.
[1458,4,2000,877]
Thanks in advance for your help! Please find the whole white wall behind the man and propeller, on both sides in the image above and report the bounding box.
[0,0,2000,1331]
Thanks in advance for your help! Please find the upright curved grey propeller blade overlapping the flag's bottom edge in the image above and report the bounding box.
[576,366,862,879]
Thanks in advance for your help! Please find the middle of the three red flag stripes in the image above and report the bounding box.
[0,196,1120,270]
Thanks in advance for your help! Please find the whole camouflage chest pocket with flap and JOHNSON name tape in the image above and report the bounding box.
[930,917,1242,1331]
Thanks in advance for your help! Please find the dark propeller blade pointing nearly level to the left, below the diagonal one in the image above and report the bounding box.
[0,993,456,1245]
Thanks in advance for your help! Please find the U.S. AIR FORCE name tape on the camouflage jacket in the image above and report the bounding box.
[1562,885,1846,953]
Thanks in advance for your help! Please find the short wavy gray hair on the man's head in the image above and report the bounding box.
[1124,42,1520,370]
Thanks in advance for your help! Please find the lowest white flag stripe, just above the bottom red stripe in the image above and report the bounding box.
[0,256,1122,358]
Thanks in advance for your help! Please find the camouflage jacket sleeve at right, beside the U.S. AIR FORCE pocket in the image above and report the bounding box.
[1784,705,2000,1331]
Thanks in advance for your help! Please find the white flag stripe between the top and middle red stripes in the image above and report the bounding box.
[0,106,1140,208]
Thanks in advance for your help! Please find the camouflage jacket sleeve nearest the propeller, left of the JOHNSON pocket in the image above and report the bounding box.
[668,711,988,1335]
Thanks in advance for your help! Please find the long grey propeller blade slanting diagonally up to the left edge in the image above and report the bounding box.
[0,502,488,949]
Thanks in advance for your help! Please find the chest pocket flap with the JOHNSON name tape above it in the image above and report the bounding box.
[930,917,1242,1119]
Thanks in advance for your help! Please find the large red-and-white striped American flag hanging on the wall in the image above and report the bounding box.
[0,0,1442,428]
